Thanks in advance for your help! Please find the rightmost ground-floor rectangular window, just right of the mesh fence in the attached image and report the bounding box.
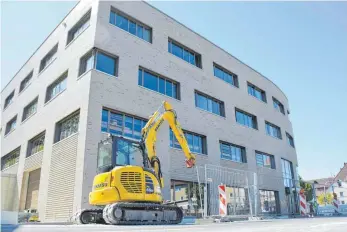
[259,189,280,214]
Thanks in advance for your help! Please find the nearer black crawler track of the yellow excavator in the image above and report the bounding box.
[103,202,183,225]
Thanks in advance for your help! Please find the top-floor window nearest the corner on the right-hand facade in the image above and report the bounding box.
[110,9,152,43]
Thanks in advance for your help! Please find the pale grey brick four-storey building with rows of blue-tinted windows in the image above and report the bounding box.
[1,1,298,222]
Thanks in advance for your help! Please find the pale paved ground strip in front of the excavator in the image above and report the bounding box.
[1,217,347,232]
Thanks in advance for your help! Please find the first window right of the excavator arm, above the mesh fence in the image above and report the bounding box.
[219,141,247,163]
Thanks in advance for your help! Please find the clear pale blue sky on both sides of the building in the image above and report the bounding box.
[1,1,347,179]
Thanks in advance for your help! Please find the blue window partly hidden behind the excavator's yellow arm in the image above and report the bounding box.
[170,128,207,155]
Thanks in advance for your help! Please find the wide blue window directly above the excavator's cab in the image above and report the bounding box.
[101,109,147,139]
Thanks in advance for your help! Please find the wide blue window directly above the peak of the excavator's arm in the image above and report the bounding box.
[138,68,179,99]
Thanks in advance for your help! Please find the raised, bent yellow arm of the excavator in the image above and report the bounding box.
[141,101,195,187]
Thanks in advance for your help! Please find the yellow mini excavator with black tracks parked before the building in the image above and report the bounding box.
[73,101,195,225]
